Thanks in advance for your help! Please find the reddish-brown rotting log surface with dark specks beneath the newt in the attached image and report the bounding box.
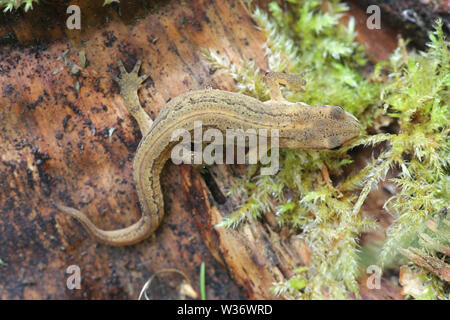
[0,0,406,299]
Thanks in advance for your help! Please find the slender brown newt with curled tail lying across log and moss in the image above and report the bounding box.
[56,60,360,246]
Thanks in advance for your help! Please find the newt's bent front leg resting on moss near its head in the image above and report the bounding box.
[264,71,306,101]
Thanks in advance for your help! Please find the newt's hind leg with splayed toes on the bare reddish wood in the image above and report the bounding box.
[114,58,153,137]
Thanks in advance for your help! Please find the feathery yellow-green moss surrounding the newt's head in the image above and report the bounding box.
[207,0,450,299]
